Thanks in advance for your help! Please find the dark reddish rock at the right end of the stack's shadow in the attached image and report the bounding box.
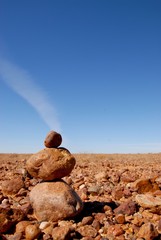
[114,201,136,215]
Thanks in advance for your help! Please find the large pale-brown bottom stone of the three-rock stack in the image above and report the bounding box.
[29,180,83,221]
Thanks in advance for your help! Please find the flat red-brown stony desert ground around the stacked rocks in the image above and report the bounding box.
[0,153,161,240]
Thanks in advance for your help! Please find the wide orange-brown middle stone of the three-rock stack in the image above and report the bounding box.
[26,148,76,181]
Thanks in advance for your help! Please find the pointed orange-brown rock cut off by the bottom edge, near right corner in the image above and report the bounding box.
[137,222,159,240]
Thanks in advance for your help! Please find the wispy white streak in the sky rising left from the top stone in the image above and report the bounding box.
[0,59,60,131]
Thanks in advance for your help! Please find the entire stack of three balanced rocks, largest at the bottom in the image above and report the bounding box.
[26,131,83,222]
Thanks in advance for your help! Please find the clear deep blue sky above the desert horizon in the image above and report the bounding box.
[0,0,161,153]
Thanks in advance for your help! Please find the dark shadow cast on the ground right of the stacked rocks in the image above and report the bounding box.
[74,201,117,222]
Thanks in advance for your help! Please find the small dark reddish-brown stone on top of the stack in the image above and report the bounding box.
[44,131,62,148]
